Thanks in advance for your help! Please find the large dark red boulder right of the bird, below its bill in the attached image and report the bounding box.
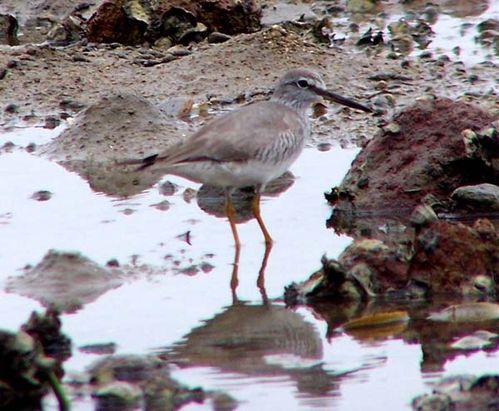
[330,99,496,216]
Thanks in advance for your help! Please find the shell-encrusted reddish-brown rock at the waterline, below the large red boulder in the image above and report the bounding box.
[285,219,499,305]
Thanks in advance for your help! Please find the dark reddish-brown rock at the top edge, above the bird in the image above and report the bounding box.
[87,0,261,45]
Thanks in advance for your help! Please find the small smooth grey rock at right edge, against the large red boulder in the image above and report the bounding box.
[451,183,499,211]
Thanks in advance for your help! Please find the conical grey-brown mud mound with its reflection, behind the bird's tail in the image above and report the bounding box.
[38,92,187,196]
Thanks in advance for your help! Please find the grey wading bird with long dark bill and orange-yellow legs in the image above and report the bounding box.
[126,69,372,249]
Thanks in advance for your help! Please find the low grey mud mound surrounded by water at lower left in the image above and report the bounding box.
[6,250,121,312]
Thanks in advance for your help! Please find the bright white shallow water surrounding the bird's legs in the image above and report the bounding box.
[0,129,499,410]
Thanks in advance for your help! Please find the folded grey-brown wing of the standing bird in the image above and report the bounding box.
[150,102,307,165]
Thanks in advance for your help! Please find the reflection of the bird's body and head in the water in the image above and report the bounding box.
[164,301,338,397]
